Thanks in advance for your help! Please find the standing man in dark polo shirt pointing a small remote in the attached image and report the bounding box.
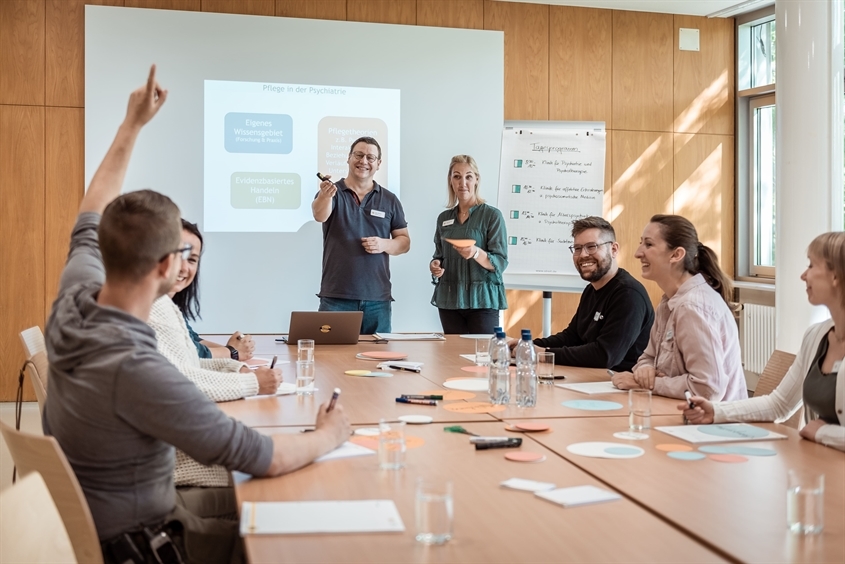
[311,137,411,335]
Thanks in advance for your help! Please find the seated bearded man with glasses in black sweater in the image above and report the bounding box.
[510,217,654,371]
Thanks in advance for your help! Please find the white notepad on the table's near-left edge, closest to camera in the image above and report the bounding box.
[241,499,405,536]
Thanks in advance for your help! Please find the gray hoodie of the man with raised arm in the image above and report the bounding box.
[43,213,273,540]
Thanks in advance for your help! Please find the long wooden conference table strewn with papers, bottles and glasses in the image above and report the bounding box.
[212,336,845,563]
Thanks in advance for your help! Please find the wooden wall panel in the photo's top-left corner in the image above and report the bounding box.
[0,0,45,106]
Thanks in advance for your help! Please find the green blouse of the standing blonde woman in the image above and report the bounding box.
[431,204,508,309]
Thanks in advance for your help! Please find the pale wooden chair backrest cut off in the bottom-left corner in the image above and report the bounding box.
[0,472,78,563]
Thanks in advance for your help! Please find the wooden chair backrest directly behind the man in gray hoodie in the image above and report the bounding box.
[0,422,103,564]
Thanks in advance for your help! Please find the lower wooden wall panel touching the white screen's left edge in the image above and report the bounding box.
[44,108,85,317]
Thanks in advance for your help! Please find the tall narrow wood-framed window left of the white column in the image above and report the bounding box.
[736,7,777,281]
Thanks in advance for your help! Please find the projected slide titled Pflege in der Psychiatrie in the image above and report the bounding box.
[203,80,400,232]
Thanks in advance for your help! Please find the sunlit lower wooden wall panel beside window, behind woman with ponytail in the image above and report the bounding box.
[673,133,734,276]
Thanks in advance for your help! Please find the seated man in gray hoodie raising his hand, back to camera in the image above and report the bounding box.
[43,66,350,563]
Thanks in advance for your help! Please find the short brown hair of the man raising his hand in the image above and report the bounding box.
[97,190,182,281]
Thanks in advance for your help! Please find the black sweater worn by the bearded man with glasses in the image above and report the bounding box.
[534,268,654,371]
